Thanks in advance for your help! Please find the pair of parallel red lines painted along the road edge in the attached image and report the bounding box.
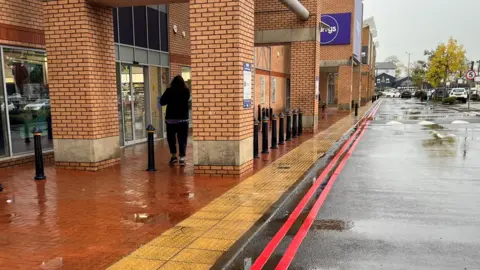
[251,103,380,270]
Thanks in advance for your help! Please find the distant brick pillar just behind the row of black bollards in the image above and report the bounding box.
[290,41,320,131]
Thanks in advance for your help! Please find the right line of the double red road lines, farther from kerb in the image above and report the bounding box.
[275,108,378,270]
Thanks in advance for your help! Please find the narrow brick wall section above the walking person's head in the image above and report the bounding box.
[168,2,191,78]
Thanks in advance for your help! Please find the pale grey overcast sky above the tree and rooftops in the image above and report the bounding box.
[363,0,480,65]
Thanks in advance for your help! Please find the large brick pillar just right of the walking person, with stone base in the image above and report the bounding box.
[190,0,254,177]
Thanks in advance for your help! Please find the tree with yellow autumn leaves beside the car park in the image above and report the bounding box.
[425,38,466,87]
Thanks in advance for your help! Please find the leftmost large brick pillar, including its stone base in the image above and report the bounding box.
[43,0,120,171]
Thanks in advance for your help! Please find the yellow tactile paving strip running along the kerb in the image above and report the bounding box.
[109,107,369,270]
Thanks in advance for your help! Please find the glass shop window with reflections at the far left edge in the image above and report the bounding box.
[4,49,53,155]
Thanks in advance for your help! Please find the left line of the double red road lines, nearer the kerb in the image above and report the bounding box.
[251,103,380,270]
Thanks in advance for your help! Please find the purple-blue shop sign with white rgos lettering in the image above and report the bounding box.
[320,13,352,45]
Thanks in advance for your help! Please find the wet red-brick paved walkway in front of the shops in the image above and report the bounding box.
[0,110,345,269]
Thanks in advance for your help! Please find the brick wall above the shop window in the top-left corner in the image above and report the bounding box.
[0,0,45,49]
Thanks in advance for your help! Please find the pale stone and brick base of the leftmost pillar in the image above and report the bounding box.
[53,136,120,171]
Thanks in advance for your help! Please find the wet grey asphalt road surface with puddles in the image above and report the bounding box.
[238,99,480,269]
